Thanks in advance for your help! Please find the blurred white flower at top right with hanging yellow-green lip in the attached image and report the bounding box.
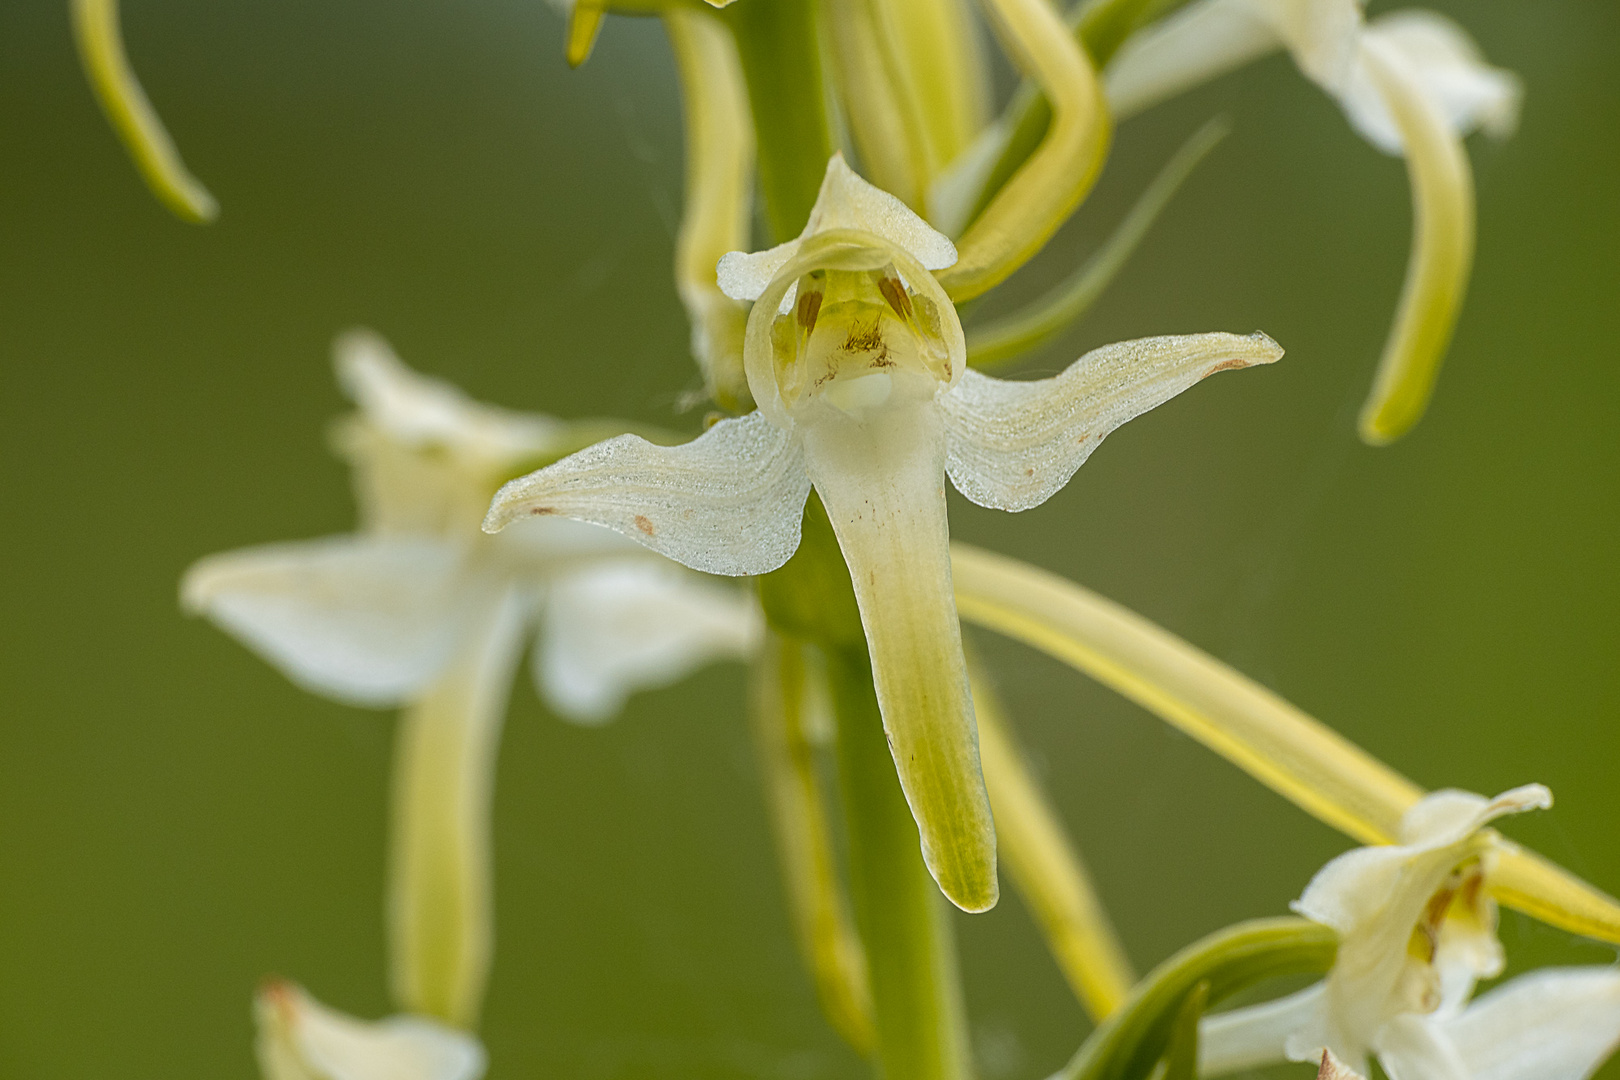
[1106,0,1523,444]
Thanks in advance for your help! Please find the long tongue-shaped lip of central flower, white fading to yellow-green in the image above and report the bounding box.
[804,376,998,912]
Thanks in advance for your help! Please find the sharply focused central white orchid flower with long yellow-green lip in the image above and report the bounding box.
[484,155,1281,912]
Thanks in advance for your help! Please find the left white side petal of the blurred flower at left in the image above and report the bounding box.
[180,536,468,706]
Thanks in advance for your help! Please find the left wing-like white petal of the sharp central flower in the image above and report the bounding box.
[484,413,810,575]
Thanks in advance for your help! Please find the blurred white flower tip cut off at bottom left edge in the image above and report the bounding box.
[253,981,486,1080]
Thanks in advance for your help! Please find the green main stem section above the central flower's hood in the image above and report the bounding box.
[724,0,833,241]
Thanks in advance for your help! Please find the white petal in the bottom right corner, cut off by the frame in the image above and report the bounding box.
[1445,967,1620,1080]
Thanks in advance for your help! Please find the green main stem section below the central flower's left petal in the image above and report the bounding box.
[760,495,970,1080]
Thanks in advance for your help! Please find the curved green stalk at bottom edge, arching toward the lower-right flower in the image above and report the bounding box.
[1053,916,1338,1080]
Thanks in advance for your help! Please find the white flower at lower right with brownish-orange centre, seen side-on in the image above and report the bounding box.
[1199,784,1620,1080]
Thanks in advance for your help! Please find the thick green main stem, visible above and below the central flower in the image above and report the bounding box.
[726,12,972,1062]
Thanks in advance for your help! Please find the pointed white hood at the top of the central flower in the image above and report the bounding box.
[718,154,956,300]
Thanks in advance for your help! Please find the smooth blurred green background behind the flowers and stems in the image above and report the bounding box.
[0,0,1620,1080]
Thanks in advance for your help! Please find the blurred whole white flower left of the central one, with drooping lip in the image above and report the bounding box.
[181,334,760,1027]
